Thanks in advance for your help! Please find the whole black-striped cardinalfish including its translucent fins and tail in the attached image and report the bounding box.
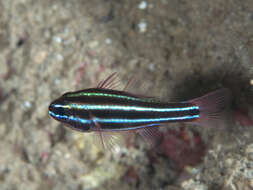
[49,73,229,148]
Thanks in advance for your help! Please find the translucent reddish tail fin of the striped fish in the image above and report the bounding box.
[189,88,231,127]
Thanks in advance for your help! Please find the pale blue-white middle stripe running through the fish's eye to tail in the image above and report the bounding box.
[53,104,199,112]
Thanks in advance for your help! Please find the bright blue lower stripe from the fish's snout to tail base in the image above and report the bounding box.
[49,111,199,124]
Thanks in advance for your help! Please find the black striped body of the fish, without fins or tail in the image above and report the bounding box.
[49,88,199,131]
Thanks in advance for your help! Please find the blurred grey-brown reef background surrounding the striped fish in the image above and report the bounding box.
[0,0,253,190]
